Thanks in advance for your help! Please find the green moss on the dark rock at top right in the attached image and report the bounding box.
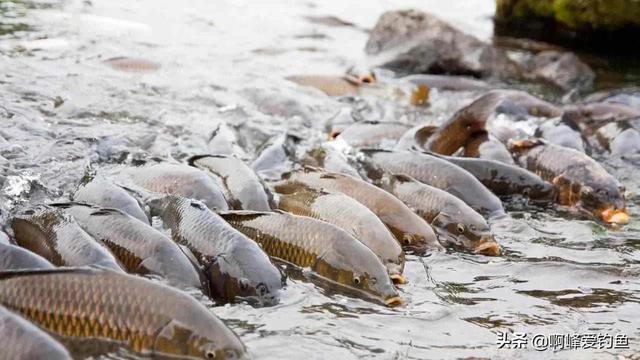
[496,0,640,30]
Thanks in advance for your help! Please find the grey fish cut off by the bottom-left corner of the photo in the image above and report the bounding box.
[0,306,71,360]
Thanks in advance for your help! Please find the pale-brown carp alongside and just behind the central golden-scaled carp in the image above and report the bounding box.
[273,181,406,284]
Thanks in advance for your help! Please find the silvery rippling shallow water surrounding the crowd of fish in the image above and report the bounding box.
[0,0,640,359]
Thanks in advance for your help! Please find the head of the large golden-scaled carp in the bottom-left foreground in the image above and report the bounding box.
[153,318,247,360]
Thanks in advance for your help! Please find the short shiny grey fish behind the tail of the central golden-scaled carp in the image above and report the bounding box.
[188,155,271,211]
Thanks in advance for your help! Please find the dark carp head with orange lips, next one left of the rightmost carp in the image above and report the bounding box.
[433,213,500,256]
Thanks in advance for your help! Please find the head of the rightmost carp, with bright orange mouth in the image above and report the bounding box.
[578,181,629,224]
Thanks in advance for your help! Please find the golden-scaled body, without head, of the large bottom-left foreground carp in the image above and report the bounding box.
[0,268,244,355]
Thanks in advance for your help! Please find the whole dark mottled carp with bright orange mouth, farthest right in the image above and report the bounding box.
[509,139,629,224]
